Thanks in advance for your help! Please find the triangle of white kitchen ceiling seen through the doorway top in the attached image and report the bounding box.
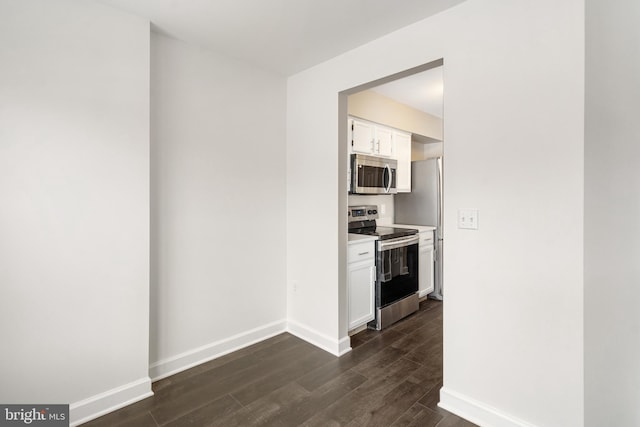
[370,67,444,118]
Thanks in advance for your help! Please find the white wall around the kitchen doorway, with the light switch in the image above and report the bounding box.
[287,0,584,427]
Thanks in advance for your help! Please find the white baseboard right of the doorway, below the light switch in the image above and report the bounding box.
[438,387,535,427]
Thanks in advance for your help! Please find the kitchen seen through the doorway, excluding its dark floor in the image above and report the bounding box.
[347,62,443,336]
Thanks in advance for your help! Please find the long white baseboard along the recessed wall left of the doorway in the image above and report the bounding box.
[149,320,287,381]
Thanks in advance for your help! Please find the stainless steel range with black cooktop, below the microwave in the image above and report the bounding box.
[349,205,419,330]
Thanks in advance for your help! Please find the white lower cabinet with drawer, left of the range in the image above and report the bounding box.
[347,240,376,330]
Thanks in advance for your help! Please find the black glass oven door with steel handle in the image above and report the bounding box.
[376,235,419,308]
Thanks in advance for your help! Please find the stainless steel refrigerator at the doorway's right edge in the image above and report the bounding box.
[394,157,444,300]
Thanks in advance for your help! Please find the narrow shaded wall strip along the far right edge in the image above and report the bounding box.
[584,0,640,427]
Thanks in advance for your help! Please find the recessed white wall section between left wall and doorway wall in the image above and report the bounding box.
[150,33,286,379]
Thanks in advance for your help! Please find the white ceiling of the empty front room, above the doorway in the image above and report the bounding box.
[100,0,464,75]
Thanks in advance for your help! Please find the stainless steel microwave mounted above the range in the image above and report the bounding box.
[351,154,398,194]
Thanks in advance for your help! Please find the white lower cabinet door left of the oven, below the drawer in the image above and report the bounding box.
[348,261,376,330]
